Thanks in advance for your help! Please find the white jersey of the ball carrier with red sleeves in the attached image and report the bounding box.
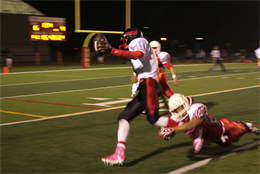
[128,37,159,81]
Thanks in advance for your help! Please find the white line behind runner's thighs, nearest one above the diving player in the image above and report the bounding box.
[0,85,260,127]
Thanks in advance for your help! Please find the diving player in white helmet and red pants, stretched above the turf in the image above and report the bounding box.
[158,93,259,153]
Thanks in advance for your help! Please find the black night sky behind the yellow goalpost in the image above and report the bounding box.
[23,0,260,51]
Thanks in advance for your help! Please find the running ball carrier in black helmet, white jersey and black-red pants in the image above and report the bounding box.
[99,28,181,166]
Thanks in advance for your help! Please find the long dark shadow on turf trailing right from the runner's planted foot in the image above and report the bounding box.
[123,142,191,167]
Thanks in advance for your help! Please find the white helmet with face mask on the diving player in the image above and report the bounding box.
[168,93,191,121]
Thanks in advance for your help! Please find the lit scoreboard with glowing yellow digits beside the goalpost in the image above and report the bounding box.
[29,16,66,41]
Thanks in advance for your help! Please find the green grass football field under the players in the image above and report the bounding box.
[0,63,260,174]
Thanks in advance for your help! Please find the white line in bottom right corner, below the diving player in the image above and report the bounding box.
[167,140,260,174]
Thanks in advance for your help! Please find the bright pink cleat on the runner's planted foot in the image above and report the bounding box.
[101,146,125,166]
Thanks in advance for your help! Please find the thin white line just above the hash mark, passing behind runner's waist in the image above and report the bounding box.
[0,72,259,99]
